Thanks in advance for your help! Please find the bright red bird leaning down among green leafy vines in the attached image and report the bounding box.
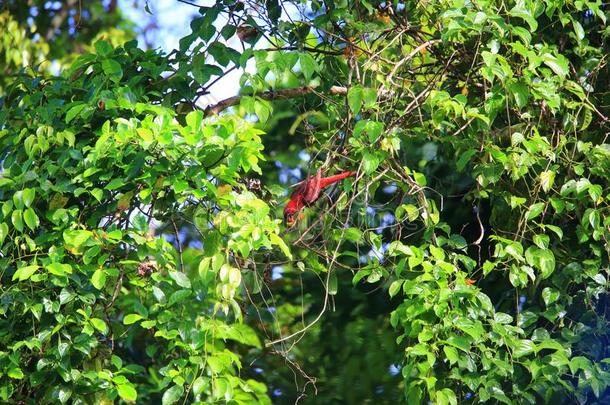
[284,169,356,226]
